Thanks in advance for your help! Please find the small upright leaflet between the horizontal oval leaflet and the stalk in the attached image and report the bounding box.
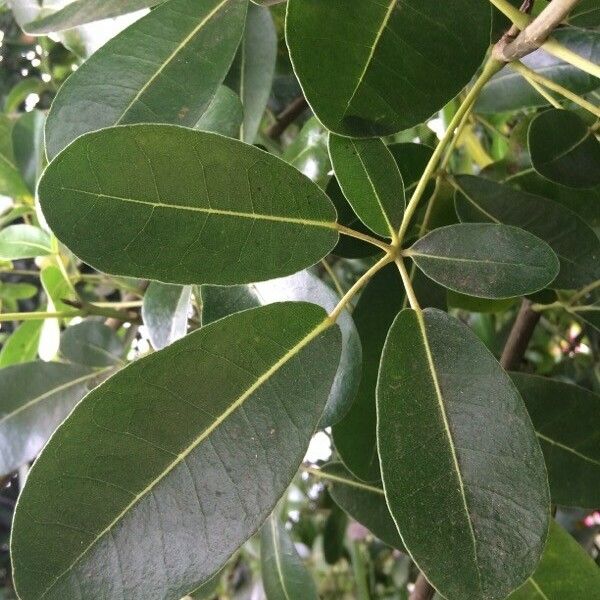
[329,134,405,238]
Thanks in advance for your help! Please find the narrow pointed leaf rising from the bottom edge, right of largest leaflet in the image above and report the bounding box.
[260,516,319,600]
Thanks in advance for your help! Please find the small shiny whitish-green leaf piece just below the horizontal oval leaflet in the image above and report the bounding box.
[142,281,192,350]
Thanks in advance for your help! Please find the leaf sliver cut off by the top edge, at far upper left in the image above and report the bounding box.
[23,0,163,35]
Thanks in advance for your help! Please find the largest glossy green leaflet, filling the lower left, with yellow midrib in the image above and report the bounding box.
[11,303,341,600]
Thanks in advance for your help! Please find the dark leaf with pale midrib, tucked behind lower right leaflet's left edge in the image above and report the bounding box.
[321,463,404,551]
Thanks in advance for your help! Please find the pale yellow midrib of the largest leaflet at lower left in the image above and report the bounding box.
[40,316,334,600]
